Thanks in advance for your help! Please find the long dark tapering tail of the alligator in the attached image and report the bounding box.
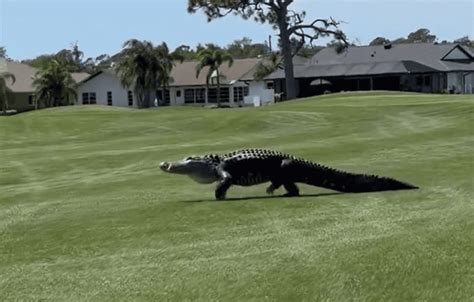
[296,160,418,193]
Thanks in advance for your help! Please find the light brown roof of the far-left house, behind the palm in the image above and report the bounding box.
[0,59,89,93]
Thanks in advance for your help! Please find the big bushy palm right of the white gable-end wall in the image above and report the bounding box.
[117,39,161,107]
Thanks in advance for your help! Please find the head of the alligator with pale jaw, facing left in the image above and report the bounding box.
[160,156,219,184]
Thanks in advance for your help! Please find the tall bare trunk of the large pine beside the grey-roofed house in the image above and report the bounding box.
[278,10,296,100]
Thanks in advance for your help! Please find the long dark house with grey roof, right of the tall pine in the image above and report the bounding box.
[266,43,474,97]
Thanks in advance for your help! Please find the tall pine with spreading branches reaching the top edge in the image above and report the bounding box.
[188,0,346,99]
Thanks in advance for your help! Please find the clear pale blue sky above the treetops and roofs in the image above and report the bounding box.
[0,0,474,60]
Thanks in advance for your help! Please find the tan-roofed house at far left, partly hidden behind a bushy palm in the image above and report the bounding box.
[0,59,89,112]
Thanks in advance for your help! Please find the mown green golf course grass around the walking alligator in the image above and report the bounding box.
[0,93,474,301]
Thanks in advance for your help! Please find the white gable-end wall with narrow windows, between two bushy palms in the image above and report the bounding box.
[77,72,137,107]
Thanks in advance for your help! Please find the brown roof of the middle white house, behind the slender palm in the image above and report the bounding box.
[170,58,261,86]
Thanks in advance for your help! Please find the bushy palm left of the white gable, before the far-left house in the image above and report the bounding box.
[33,60,77,107]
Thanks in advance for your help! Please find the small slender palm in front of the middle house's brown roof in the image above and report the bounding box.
[196,48,234,107]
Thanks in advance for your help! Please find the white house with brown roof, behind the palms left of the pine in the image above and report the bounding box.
[78,58,273,107]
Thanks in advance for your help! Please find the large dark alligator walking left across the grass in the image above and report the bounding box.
[160,149,418,200]
